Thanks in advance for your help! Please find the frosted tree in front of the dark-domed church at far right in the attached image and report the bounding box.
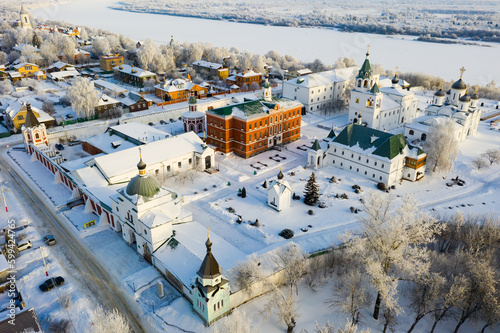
[423,119,458,172]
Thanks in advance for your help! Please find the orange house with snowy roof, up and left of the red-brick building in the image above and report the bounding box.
[155,79,208,101]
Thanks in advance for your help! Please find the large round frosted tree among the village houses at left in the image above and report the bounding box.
[67,77,99,118]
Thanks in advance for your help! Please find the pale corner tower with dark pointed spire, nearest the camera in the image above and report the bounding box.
[191,230,231,325]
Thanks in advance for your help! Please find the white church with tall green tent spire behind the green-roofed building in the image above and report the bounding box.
[349,52,418,131]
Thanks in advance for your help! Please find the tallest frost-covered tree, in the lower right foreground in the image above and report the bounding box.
[346,192,441,319]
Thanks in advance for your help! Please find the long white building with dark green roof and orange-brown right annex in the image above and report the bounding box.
[307,124,427,186]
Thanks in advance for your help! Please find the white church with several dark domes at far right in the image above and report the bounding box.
[405,68,482,143]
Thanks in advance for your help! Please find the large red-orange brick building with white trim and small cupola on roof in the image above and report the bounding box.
[206,81,302,158]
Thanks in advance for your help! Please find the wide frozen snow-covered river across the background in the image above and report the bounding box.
[32,0,500,85]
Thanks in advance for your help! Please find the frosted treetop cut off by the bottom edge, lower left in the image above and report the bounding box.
[85,306,132,333]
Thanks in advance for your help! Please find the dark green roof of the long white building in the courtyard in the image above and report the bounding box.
[333,124,410,160]
